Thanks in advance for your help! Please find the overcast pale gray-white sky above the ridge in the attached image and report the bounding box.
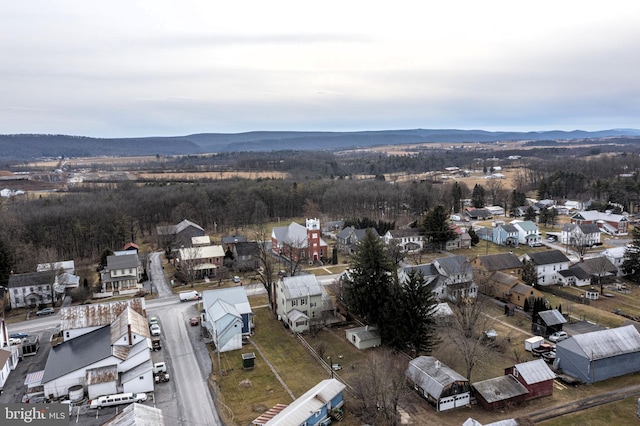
[0,0,640,137]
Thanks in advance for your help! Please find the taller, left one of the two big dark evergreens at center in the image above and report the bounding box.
[344,229,395,326]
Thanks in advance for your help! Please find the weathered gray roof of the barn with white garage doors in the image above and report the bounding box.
[406,356,468,399]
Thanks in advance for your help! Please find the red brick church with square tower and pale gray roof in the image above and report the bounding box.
[271,219,327,263]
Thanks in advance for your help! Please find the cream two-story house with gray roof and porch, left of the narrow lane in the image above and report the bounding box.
[100,251,143,296]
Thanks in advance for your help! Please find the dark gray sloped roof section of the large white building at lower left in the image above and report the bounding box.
[42,326,115,383]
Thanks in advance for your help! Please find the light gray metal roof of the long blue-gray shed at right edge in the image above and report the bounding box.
[556,325,640,361]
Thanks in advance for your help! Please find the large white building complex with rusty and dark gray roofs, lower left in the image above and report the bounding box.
[41,299,154,398]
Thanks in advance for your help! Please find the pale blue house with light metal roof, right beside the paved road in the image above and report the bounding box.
[202,286,254,352]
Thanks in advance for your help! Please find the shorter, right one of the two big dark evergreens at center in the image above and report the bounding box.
[383,270,438,356]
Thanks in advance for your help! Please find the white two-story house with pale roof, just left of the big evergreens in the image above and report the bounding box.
[275,274,331,333]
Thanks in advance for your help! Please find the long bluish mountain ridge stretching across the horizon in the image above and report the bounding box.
[0,129,640,159]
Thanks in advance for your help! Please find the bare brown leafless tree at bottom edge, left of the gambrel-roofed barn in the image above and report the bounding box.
[353,348,411,425]
